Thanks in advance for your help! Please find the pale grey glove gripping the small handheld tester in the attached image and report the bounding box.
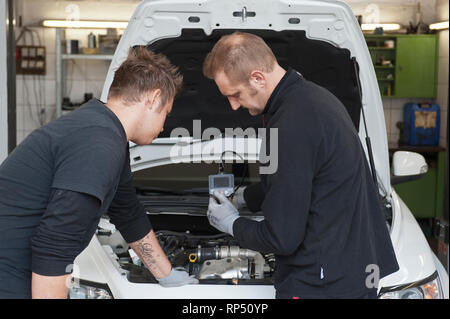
[207,192,239,236]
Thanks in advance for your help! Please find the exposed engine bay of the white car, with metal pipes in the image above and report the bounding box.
[97,215,275,285]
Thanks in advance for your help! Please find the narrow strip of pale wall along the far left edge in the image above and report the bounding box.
[0,0,8,163]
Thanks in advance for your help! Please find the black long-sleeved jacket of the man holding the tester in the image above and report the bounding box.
[233,69,398,298]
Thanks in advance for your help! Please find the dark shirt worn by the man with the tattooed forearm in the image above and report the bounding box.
[0,99,151,293]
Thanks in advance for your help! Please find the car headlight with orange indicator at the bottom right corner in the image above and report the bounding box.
[379,272,444,299]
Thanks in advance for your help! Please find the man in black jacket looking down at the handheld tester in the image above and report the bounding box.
[203,32,398,298]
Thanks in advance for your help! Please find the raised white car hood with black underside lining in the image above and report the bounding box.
[101,0,390,198]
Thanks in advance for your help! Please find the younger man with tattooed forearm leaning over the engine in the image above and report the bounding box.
[0,47,198,298]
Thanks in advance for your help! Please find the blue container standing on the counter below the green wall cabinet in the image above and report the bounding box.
[403,103,441,146]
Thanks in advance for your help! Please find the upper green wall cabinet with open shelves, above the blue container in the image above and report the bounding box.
[365,34,438,98]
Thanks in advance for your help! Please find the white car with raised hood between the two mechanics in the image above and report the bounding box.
[70,0,448,299]
